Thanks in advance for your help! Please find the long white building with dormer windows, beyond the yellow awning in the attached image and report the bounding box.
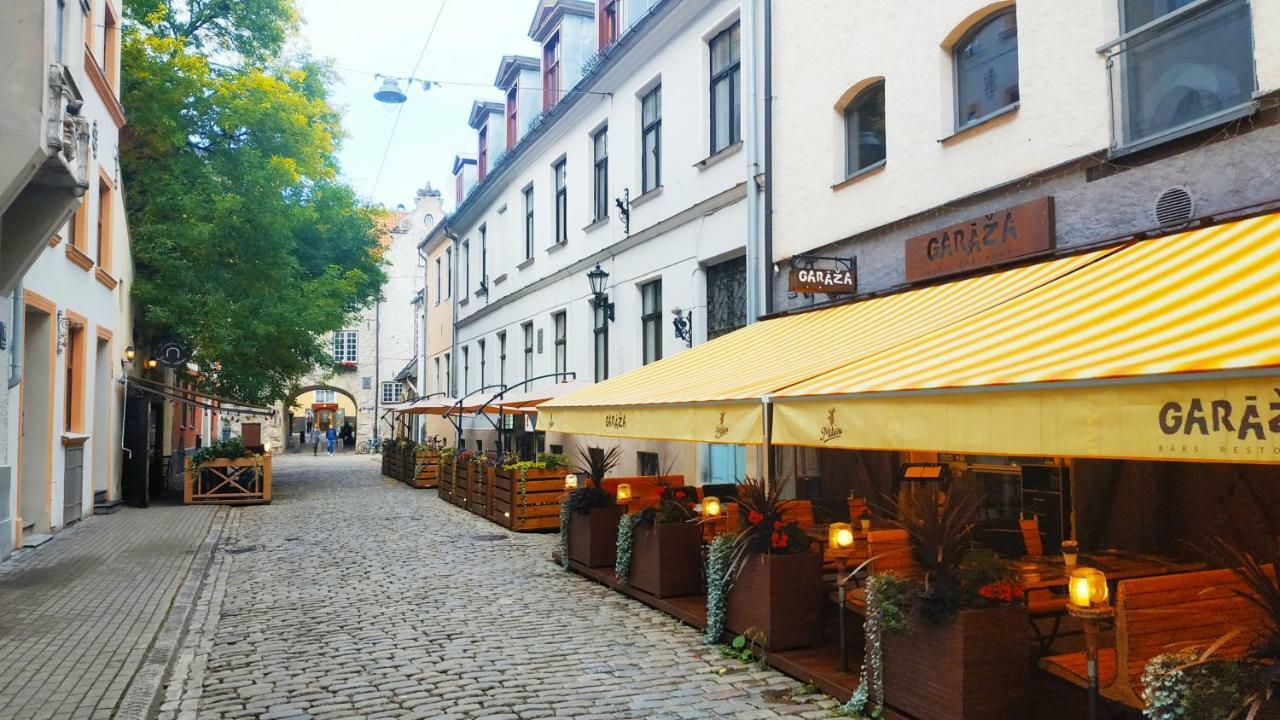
[445,0,755,483]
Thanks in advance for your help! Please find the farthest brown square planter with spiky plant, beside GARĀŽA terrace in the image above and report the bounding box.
[561,446,622,568]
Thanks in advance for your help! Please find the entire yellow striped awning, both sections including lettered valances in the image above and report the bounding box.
[541,210,1280,462]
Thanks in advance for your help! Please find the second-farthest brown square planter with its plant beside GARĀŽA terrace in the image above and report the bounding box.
[614,484,703,597]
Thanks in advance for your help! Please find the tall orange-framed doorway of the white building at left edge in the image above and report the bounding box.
[18,298,58,536]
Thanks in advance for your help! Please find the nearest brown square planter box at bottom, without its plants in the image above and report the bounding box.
[883,607,1030,720]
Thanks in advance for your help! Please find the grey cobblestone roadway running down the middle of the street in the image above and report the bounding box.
[161,456,836,720]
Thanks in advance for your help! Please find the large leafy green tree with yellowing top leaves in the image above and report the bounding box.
[120,0,385,404]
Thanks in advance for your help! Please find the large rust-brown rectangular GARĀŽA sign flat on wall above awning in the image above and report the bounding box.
[906,197,1053,282]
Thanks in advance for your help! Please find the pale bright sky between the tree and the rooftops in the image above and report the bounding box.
[297,0,538,208]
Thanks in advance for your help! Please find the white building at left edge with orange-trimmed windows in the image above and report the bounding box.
[0,0,133,556]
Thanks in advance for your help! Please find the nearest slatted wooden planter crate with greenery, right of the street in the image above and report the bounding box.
[489,452,572,530]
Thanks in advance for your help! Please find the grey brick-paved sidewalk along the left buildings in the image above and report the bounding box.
[0,506,218,720]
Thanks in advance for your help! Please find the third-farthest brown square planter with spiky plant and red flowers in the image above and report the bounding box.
[707,478,822,651]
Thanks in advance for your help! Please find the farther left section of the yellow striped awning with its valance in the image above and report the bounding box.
[540,245,1111,445]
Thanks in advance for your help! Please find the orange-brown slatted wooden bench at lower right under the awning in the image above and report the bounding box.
[1039,570,1265,708]
